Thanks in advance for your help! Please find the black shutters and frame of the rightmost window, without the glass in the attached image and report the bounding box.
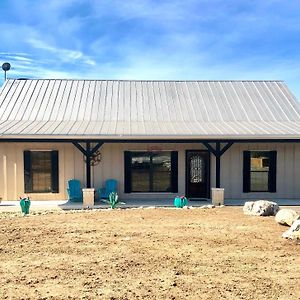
[243,150,277,193]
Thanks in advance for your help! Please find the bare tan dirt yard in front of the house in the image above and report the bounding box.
[0,207,300,300]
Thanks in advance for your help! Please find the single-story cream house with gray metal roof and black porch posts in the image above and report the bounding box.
[0,79,300,200]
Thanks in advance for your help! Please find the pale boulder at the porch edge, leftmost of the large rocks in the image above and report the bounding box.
[243,200,279,216]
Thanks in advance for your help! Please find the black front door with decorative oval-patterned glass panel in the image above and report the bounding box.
[185,150,210,199]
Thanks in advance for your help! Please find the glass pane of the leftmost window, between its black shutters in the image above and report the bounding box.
[31,151,51,192]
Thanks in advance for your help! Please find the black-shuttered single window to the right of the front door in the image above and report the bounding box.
[243,151,277,193]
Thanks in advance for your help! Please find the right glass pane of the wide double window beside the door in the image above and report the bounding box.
[152,152,172,192]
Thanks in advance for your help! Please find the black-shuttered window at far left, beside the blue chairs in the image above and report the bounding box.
[24,151,58,193]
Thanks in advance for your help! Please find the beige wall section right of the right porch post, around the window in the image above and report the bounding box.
[221,143,300,199]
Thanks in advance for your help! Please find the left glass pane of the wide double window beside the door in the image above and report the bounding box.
[131,153,150,192]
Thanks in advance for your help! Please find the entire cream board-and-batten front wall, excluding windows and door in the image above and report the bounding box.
[0,143,300,200]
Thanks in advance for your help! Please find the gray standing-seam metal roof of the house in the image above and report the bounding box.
[0,79,300,139]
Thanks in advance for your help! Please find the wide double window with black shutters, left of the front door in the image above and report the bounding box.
[125,151,178,193]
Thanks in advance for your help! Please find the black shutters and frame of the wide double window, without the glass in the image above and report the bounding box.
[124,150,178,193]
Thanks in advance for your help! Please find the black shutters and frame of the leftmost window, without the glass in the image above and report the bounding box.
[23,150,59,194]
